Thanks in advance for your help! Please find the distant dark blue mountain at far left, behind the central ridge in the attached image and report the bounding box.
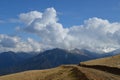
[0,51,34,70]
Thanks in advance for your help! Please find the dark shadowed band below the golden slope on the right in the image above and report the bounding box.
[79,63,120,75]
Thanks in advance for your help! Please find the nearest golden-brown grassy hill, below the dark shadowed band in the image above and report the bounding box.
[0,65,120,80]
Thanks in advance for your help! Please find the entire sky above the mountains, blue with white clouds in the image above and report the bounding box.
[0,0,120,52]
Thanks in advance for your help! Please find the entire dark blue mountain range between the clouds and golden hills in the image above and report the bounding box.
[0,48,117,75]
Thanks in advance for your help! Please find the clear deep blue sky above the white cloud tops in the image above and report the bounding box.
[0,0,120,32]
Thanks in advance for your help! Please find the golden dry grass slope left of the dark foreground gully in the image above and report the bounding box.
[0,66,87,80]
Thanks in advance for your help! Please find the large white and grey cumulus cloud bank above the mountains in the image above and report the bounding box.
[0,8,120,52]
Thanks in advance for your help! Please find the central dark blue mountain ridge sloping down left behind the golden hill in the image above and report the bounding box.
[0,48,119,75]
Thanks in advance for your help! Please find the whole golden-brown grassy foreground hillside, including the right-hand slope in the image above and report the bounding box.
[0,55,120,80]
